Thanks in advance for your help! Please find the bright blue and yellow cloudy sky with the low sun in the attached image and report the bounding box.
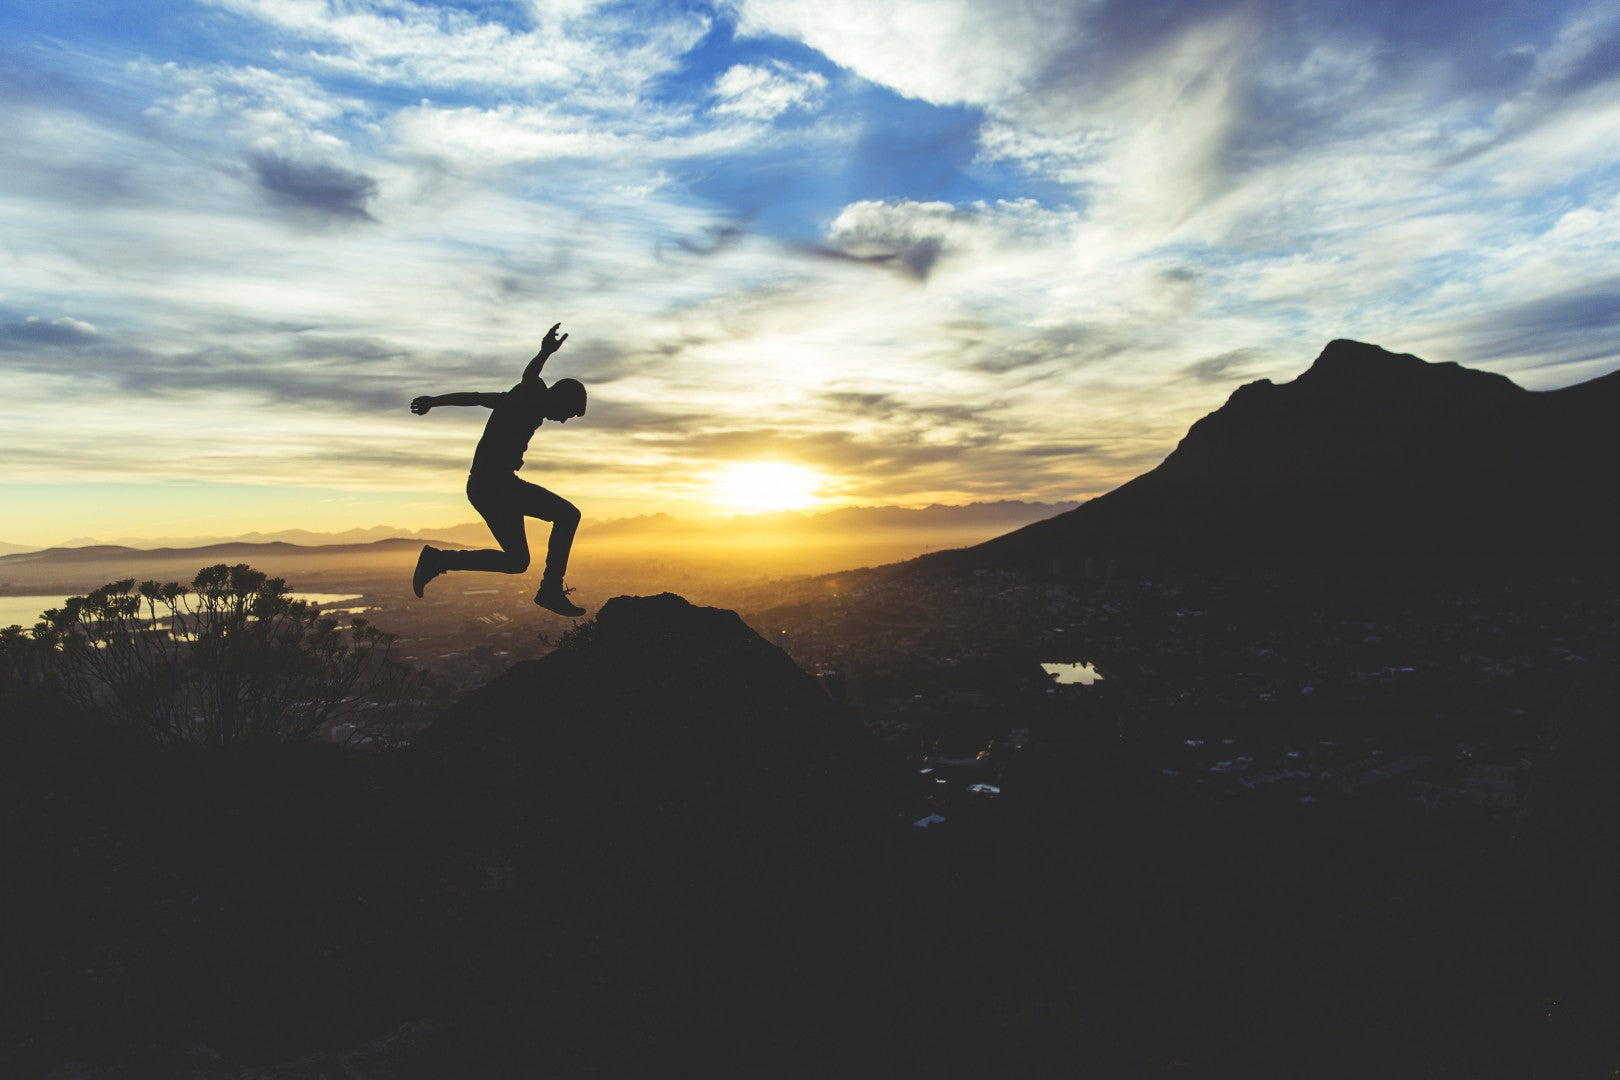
[0,0,1620,544]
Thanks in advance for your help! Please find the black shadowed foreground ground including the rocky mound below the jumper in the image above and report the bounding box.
[0,592,1620,1078]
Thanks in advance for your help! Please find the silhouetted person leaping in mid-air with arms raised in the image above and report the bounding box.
[410,322,585,615]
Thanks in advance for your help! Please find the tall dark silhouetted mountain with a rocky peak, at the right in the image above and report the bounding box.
[915,340,1620,572]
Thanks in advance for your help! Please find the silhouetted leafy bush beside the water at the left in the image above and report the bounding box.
[17,563,426,746]
